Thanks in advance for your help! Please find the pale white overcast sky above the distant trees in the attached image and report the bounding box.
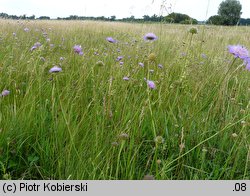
[0,0,250,20]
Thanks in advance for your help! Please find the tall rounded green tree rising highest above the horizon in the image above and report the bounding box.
[218,0,242,25]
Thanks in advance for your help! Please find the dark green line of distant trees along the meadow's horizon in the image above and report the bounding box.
[0,0,250,26]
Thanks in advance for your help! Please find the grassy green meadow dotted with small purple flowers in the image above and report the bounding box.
[0,20,250,180]
